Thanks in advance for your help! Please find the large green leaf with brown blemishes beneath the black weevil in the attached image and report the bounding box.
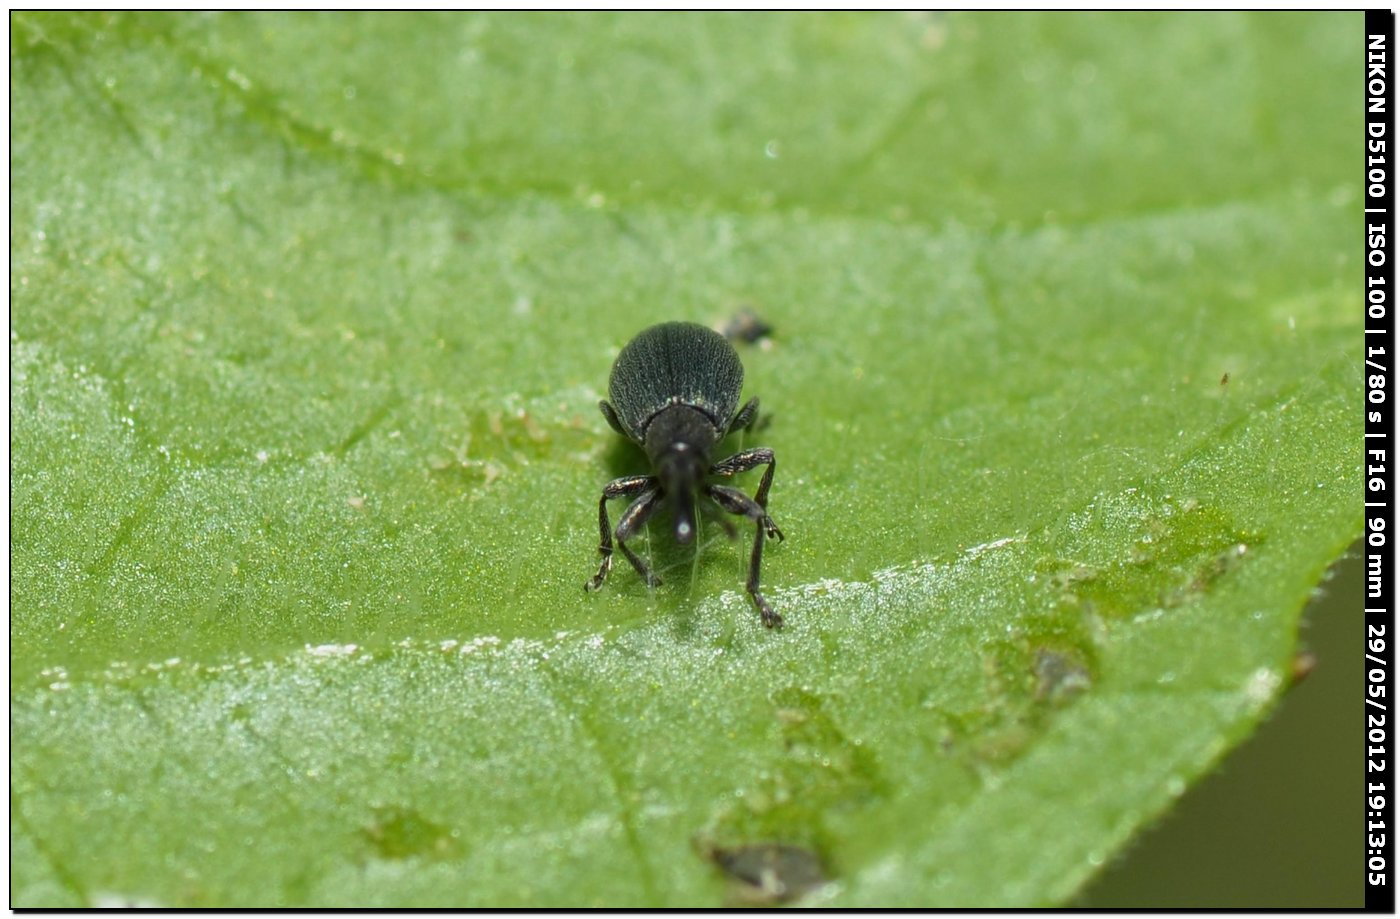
[10,14,1361,906]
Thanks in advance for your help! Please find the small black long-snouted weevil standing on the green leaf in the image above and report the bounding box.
[584,322,783,629]
